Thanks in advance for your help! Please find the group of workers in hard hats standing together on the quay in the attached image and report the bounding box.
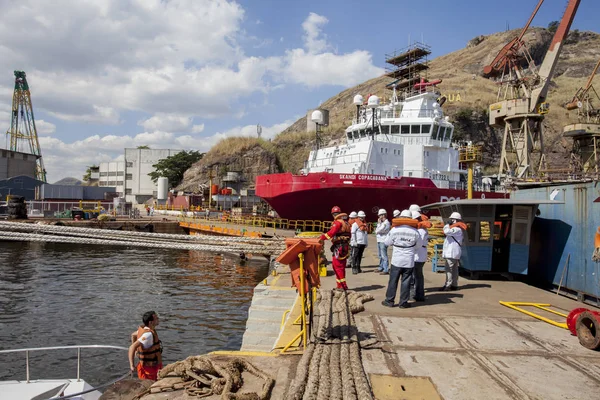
[321,204,467,308]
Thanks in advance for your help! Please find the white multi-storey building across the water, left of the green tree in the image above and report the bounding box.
[99,149,182,206]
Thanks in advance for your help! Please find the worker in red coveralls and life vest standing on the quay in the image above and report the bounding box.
[320,206,351,290]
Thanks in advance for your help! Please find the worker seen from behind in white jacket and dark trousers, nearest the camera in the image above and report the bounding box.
[381,210,423,308]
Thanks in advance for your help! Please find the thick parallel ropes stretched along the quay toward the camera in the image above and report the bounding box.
[286,290,373,400]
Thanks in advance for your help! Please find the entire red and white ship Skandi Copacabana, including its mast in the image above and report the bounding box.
[256,47,505,221]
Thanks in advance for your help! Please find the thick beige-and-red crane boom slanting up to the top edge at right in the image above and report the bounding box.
[529,0,581,112]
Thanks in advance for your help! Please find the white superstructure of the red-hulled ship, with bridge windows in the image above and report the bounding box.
[304,86,466,188]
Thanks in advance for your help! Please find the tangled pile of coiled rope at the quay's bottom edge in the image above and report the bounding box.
[144,356,275,400]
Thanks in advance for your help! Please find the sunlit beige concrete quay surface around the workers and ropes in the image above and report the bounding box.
[126,220,600,400]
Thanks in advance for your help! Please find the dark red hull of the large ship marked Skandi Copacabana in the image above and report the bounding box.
[256,172,505,221]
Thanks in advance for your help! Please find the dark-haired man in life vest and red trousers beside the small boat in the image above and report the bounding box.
[129,311,162,381]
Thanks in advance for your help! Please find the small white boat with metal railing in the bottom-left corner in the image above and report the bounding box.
[0,345,130,400]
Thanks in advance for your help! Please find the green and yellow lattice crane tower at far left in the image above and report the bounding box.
[6,71,46,182]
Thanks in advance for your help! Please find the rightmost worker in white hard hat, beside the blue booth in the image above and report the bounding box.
[440,212,467,290]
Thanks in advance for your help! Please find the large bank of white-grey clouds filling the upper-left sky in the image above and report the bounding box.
[0,5,383,180]
